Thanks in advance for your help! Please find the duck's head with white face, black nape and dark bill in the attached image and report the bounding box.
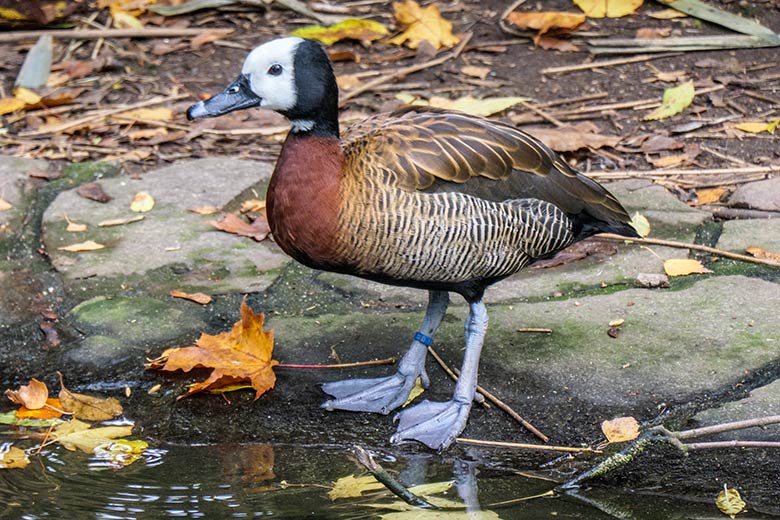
[187,37,338,135]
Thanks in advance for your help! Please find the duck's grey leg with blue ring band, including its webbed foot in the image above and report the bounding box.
[322,291,450,414]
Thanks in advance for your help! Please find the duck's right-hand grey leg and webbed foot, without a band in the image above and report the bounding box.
[390,299,488,450]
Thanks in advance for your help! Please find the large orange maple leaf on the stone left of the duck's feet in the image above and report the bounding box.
[149,301,279,399]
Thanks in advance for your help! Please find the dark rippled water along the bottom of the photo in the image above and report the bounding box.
[0,445,769,520]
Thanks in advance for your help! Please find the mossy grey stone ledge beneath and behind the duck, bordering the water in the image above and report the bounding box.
[0,155,780,503]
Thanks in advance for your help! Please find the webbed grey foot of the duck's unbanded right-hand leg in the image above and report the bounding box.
[390,399,471,450]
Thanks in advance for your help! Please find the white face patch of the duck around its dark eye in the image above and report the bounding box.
[241,37,303,111]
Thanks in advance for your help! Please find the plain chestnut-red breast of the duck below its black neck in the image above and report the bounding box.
[266,133,344,269]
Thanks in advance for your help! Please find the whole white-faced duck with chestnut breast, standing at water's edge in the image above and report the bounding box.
[187,37,638,451]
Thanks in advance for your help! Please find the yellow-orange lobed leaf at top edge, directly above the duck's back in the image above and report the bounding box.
[390,0,460,49]
